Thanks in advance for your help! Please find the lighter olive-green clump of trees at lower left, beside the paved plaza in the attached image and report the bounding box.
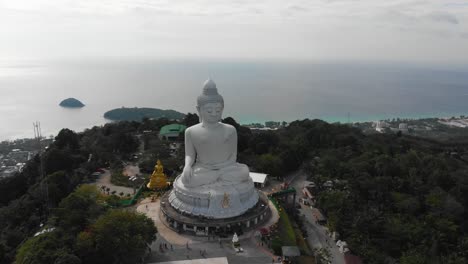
[15,185,157,264]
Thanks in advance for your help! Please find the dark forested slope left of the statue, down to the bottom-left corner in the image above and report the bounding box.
[0,122,156,263]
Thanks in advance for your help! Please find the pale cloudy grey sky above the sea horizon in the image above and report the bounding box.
[0,0,468,65]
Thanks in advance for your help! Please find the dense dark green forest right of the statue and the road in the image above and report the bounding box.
[240,120,468,264]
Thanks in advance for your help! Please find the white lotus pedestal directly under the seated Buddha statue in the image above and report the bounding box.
[169,176,258,219]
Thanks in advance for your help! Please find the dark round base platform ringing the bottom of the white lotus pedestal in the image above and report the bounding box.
[161,190,271,237]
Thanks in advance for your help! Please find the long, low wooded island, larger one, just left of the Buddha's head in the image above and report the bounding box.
[104,107,185,121]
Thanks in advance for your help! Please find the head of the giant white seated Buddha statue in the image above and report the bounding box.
[197,79,224,124]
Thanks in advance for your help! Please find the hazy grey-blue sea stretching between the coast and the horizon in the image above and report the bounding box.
[0,59,468,140]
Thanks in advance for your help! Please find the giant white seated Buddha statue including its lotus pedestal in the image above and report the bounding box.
[169,80,258,218]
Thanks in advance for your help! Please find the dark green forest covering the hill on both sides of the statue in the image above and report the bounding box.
[0,114,468,264]
